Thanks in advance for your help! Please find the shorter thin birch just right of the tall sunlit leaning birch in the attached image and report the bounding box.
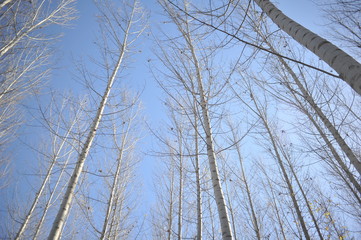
[98,93,141,239]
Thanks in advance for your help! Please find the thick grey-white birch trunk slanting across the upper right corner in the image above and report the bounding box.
[254,0,361,94]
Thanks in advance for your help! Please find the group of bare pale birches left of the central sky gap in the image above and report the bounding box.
[1,0,146,239]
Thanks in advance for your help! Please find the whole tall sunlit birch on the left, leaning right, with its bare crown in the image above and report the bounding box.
[49,1,143,239]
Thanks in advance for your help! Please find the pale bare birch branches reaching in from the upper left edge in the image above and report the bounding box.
[0,0,76,184]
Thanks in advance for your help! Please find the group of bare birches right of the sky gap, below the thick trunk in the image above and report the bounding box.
[152,0,361,239]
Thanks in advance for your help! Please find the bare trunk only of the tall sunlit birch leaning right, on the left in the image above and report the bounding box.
[48,0,136,240]
